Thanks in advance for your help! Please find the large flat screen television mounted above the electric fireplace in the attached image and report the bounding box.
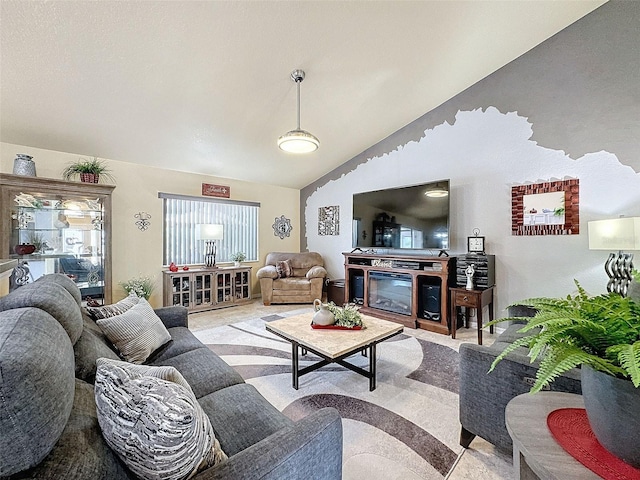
[352,180,449,251]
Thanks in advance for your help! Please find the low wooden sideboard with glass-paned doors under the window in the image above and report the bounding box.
[163,267,251,312]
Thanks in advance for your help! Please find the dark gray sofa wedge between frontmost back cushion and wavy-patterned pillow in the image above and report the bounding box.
[20,379,137,480]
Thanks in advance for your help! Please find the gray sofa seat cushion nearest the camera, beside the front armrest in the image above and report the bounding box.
[198,383,293,457]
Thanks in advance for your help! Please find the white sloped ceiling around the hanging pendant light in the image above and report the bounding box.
[0,0,603,188]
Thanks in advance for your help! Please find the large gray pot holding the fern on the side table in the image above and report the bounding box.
[581,365,640,468]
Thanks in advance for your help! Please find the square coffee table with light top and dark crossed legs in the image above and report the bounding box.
[266,313,404,391]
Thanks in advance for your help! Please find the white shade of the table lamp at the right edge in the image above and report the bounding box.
[589,217,640,250]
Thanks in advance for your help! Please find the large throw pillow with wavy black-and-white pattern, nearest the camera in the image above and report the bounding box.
[95,359,227,480]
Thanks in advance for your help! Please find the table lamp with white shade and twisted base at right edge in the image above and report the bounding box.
[589,217,640,297]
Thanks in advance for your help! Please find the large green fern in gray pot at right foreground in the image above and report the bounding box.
[487,280,640,468]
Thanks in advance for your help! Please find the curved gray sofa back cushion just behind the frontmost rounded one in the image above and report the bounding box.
[0,282,82,343]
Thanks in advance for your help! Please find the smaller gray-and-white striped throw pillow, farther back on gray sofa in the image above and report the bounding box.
[96,298,171,363]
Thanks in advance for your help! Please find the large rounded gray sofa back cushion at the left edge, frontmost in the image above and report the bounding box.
[0,308,77,476]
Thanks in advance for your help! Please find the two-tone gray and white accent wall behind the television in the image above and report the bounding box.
[300,0,640,314]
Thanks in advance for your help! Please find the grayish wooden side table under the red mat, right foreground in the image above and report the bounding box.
[505,392,601,480]
